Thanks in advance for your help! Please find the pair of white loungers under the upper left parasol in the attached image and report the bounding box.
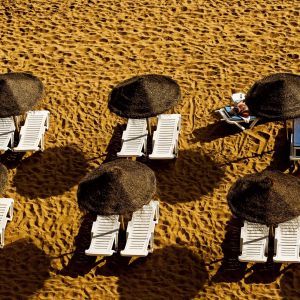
[0,110,50,152]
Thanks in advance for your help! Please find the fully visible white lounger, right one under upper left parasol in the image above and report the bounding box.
[14,110,50,152]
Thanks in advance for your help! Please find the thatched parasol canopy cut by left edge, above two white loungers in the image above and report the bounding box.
[0,73,44,118]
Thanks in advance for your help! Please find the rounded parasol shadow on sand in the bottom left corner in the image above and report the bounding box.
[0,239,50,299]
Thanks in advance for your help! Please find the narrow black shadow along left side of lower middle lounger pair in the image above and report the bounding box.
[57,213,100,278]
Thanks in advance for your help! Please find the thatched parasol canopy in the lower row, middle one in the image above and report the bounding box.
[77,159,156,215]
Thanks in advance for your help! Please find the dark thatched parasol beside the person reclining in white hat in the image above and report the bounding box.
[245,73,300,120]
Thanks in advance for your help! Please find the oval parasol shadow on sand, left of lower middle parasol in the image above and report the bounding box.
[13,145,88,199]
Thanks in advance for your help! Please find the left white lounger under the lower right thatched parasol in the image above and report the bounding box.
[239,221,269,262]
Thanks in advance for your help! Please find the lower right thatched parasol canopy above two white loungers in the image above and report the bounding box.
[227,170,300,226]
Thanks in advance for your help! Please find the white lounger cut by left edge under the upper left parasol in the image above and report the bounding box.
[0,117,16,151]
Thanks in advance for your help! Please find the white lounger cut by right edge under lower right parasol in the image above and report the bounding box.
[273,217,300,263]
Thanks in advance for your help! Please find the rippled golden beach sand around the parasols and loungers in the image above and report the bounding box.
[0,0,300,299]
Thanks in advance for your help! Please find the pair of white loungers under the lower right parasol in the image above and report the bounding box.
[239,217,300,263]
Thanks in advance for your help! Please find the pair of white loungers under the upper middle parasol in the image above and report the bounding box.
[117,114,181,159]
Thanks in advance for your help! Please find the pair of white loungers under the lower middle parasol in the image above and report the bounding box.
[85,200,159,256]
